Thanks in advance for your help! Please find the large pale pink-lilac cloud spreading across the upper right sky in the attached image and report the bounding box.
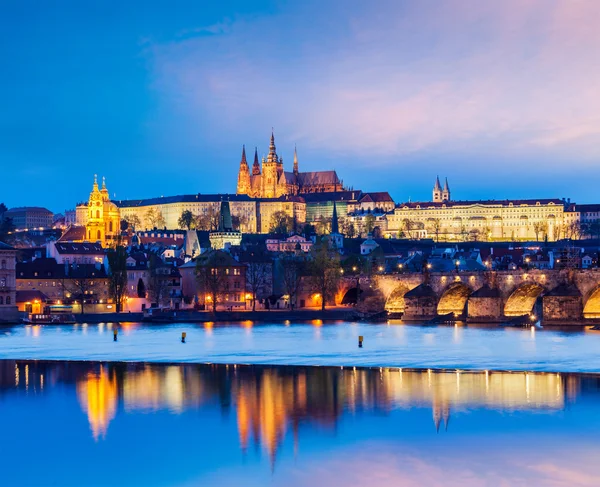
[151,0,600,164]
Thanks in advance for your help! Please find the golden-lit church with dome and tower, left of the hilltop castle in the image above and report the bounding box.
[85,175,121,246]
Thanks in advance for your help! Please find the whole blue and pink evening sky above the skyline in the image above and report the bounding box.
[0,0,600,212]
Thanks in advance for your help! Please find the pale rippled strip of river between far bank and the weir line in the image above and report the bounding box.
[0,321,600,372]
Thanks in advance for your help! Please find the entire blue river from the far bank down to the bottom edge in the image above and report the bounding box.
[0,322,600,487]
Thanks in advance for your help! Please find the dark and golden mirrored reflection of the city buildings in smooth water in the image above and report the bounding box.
[0,360,600,464]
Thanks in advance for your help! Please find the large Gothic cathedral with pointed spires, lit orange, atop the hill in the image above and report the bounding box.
[237,133,344,198]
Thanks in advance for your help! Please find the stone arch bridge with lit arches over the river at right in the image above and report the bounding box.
[337,269,600,324]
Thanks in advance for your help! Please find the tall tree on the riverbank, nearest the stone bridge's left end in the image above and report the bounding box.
[309,238,341,311]
